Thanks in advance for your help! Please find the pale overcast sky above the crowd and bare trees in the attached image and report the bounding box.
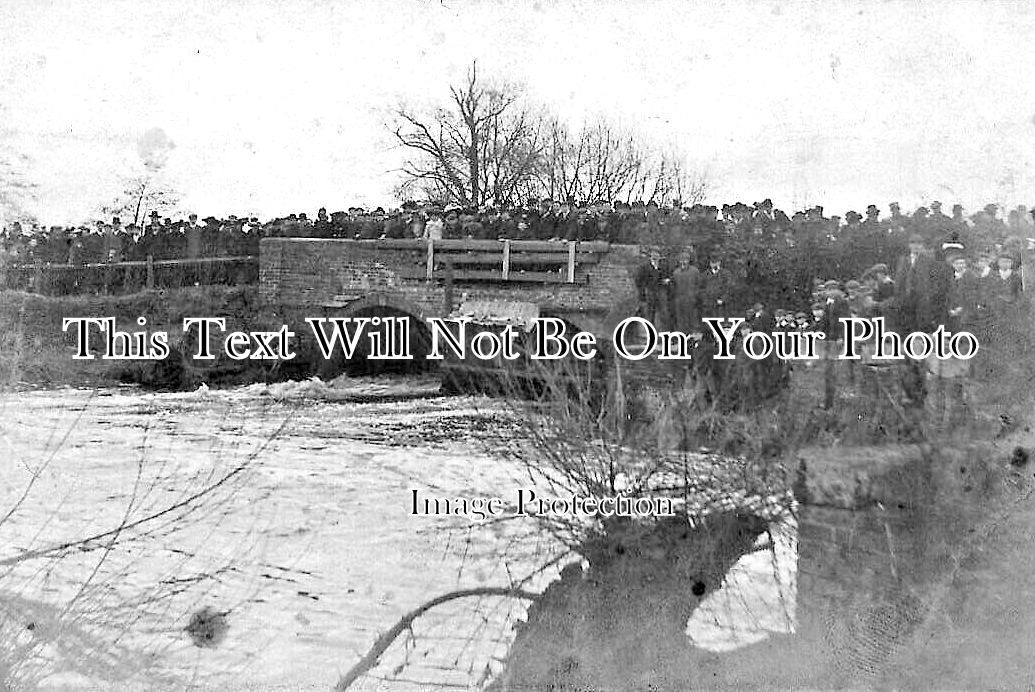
[0,0,1035,222]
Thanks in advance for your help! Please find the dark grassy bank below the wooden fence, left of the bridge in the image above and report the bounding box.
[0,285,261,387]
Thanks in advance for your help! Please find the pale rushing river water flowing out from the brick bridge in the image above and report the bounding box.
[0,381,795,689]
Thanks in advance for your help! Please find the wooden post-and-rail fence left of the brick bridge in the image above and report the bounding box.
[0,255,259,295]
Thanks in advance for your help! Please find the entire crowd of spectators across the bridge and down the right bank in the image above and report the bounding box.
[0,200,1035,417]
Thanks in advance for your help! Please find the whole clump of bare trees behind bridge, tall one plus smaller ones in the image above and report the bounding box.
[390,63,705,207]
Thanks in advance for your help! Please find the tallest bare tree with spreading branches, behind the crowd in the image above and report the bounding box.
[391,62,542,207]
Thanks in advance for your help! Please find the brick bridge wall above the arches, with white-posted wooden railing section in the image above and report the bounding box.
[259,238,642,336]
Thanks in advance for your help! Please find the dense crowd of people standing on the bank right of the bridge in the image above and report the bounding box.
[612,203,1035,420]
